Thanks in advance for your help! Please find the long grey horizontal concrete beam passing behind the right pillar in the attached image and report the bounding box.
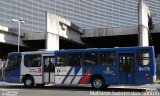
[81,24,160,38]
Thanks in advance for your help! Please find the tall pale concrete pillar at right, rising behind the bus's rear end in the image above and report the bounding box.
[138,0,150,46]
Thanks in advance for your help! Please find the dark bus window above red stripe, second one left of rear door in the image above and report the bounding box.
[83,52,98,66]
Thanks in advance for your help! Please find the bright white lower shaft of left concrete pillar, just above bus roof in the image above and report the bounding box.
[46,32,59,51]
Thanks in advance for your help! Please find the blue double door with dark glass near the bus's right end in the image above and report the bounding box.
[118,53,135,84]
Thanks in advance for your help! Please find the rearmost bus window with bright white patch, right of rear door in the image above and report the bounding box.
[137,50,150,65]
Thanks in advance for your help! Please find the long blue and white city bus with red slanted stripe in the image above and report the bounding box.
[4,46,156,89]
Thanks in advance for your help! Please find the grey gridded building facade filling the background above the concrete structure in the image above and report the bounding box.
[0,0,160,32]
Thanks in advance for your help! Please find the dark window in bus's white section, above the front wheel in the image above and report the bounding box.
[24,54,41,67]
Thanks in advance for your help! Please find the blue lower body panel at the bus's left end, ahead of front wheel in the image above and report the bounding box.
[5,67,20,83]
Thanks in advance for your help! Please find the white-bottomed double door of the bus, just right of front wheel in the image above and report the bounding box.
[43,56,55,83]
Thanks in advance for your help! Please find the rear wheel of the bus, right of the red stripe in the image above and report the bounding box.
[91,76,105,90]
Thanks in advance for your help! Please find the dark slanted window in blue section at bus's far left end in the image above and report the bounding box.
[7,55,21,69]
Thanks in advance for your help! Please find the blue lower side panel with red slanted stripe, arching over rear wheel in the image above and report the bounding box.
[79,66,118,85]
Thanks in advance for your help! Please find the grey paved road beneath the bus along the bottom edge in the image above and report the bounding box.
[0,83,160,96]
